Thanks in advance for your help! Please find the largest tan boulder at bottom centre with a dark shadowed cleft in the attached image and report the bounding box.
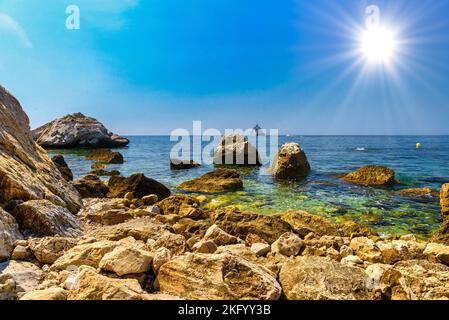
[157,252,281,300]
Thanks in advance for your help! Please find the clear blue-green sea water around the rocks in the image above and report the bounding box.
[49,136,449,237]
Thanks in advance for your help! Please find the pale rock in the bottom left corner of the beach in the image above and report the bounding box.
[0,260,43,300]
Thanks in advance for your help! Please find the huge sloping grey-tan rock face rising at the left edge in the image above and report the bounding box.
[0,86,82,212]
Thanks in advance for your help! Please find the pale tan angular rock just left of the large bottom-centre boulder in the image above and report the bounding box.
[99,246,153,276]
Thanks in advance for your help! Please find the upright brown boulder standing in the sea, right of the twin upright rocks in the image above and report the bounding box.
[270,142,310,180]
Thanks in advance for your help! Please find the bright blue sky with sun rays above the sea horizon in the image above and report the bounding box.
[0,0,449,134]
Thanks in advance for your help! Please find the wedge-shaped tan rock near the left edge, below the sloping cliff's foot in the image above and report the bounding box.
[28,237,77,264]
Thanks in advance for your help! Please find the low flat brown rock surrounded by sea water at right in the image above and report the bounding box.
[343,166,396,186]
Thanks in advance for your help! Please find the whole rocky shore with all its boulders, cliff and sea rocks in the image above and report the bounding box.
[0,87,449,300]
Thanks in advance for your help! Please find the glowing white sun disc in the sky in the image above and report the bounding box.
[361,27,397,63]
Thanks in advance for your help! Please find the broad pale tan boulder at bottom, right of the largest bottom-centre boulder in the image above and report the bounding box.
[279,257,370,300]
